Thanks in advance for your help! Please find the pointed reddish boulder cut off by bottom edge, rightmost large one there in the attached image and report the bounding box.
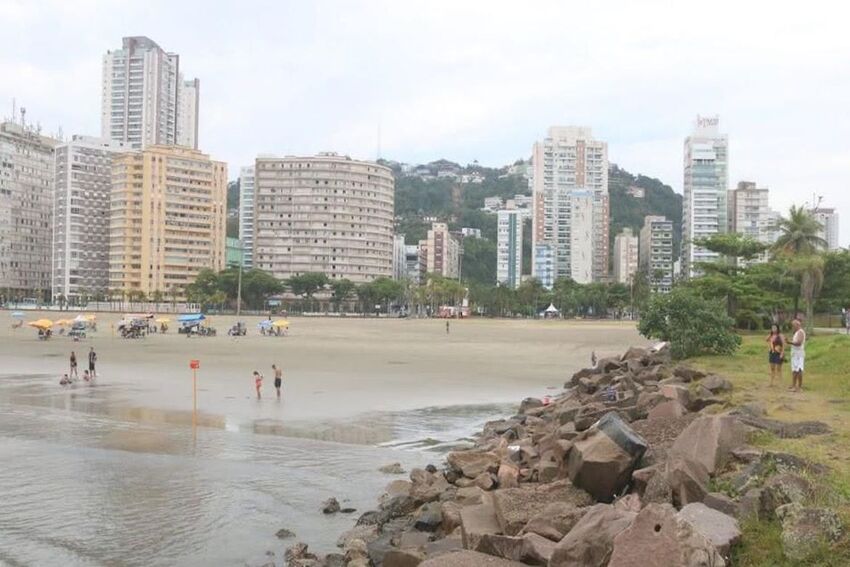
[608,504,726,567]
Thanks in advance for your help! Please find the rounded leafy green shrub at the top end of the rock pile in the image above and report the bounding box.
[638,287,741,359]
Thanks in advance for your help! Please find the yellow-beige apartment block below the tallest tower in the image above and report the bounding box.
[109,145,227,298]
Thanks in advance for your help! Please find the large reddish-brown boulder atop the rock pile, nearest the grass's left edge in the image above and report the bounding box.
[670,415,746,474]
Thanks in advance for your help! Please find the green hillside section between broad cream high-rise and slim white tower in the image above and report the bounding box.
[608,165,682,257]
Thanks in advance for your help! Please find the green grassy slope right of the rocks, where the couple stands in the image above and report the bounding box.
[693,335,850,566]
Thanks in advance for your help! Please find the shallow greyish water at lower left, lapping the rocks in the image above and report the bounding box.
[0,375,511,566]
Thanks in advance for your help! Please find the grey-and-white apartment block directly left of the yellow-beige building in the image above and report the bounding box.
[51,136,129,304]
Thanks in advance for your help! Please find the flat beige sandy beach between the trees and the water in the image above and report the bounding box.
[0,312,646,426]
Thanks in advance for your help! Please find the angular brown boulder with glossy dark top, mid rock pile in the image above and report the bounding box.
[567,412,647,502]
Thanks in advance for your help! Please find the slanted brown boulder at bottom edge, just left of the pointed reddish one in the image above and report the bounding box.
[549,504,635,567]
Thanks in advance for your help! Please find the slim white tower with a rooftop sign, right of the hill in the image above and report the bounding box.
[682,116,729,277]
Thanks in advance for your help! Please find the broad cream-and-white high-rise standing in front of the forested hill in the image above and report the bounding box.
[531,126,609,288]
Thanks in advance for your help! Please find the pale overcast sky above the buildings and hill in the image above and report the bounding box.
[0,0,850,246]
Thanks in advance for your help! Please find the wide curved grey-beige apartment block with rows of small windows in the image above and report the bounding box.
[253,153,395,283]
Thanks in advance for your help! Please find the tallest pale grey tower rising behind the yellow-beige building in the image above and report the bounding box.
[101,36,199,148]
